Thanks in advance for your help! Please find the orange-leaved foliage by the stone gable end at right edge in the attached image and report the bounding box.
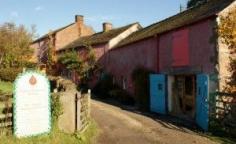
[218,7,236,95]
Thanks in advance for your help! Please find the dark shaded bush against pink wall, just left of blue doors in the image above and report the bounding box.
[132,67,152,111]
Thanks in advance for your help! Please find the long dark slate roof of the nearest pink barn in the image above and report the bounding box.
[116,0,235,47]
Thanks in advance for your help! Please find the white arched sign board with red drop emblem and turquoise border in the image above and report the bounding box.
[13,71,51,137]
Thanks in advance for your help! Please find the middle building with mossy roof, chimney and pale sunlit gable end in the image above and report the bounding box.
[57,23,141,85]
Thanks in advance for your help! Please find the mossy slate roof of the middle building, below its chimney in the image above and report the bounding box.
[60,23,141,50]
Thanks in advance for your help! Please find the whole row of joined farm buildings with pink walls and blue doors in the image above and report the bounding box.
[31,0,236,130]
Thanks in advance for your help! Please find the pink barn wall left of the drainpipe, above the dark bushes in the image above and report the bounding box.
[105,38,157,93]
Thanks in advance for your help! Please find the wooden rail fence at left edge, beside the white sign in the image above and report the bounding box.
[0,94,13,134]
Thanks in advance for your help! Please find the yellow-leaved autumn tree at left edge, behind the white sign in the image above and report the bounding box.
[0,23,35,68]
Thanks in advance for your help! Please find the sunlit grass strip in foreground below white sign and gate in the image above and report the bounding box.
[0,120,97,144]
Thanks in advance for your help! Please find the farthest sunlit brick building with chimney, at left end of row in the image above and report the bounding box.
[31,15,94,63]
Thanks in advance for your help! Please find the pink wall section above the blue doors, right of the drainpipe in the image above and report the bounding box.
[159,20,215,74]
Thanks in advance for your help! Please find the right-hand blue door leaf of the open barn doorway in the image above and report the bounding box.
[196,74,209,131]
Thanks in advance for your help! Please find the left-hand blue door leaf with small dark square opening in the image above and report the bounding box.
[150,74,166,114]
